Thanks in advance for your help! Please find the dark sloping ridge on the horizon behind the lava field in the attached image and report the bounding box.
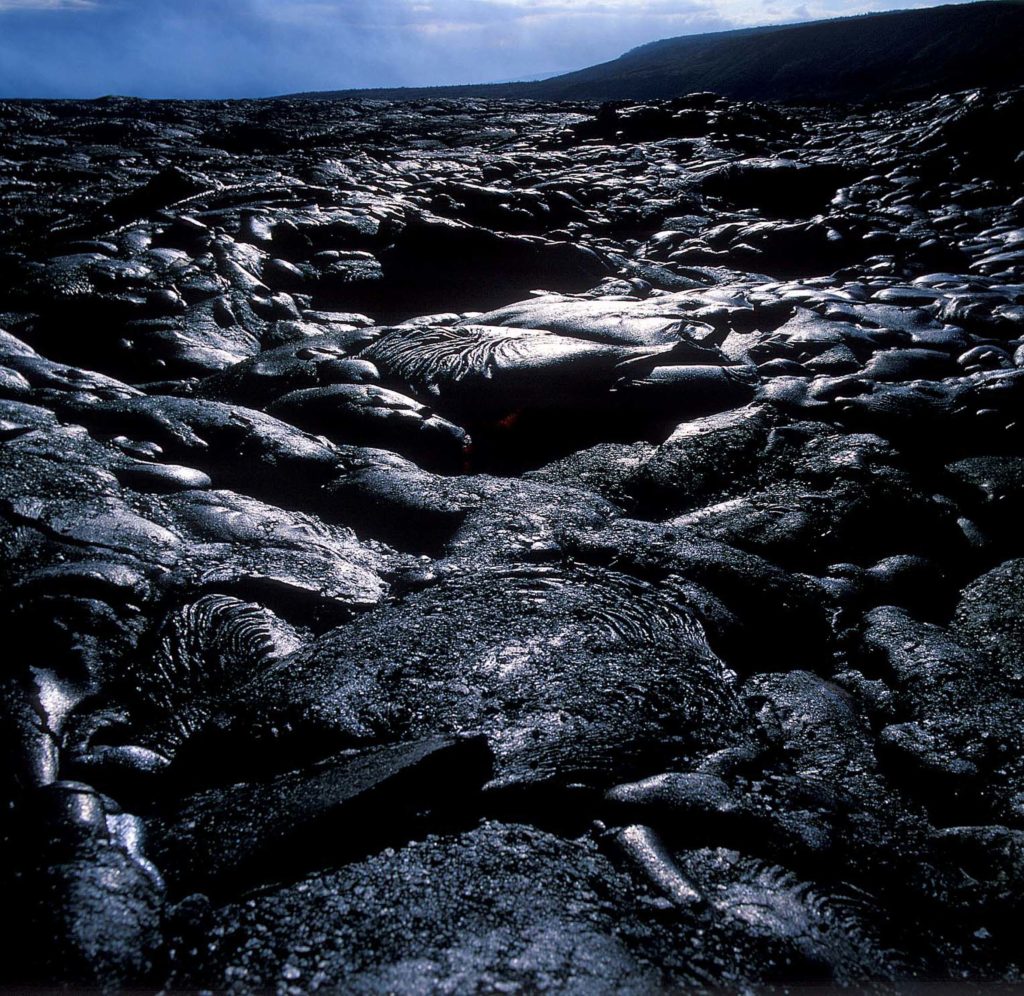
[286,0,1024,102]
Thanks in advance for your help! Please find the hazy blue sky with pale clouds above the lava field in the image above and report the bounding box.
[0,0,954,98]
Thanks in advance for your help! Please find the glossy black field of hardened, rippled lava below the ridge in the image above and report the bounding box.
[0,91,1024,993]
